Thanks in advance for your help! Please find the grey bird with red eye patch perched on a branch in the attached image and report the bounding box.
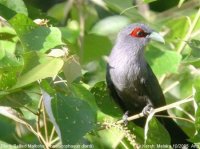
[106,23,196,148]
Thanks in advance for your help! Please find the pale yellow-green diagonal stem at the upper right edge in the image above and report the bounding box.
[177,8,200,53]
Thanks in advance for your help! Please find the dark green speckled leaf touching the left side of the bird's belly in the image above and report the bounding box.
[91,81,122,117]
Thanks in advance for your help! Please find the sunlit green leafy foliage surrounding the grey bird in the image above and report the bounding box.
[0,0,200,149]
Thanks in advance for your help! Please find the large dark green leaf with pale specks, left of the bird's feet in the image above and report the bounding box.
[51,94,96,144]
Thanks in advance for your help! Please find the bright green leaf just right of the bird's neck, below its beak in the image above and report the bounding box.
[146,45,181,76]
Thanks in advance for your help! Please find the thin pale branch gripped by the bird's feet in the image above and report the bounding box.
[117,95,194,124]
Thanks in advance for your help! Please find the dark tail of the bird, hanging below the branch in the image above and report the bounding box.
[158,118,197,149]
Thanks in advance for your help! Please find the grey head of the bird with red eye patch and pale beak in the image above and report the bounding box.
[117,23,164,50]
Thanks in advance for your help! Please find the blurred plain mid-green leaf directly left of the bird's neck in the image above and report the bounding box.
[83,34,112,63]
